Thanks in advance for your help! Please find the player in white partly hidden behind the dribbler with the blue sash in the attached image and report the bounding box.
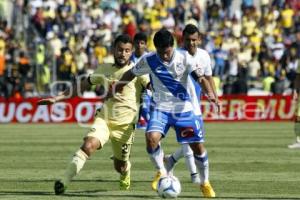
[164,24,220,184]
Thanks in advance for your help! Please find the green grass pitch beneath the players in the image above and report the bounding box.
[0,122,300,200]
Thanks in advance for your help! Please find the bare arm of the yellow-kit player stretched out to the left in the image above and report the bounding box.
[37,78,90,105]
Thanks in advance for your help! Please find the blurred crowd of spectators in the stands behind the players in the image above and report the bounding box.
[0,0,300,98]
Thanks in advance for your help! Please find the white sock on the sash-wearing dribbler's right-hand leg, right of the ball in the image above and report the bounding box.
[194,151,209,184]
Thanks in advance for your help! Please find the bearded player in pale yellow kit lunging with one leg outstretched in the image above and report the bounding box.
[38,35,149,195]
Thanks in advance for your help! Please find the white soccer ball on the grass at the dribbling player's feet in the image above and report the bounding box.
[157,176,181,198]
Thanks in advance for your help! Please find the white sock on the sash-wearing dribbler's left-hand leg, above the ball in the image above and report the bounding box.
[147,145,167,174]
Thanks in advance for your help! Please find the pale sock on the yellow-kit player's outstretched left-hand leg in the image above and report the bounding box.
[62,149,88,186]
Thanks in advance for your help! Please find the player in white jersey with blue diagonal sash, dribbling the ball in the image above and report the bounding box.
[111,29,216,197]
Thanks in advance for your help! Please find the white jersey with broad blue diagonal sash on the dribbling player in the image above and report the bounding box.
[132,50,201,115]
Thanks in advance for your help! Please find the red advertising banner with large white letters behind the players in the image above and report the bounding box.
[0,96,296,123]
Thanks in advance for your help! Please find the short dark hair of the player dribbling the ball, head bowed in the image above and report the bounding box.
[153,28,174,48]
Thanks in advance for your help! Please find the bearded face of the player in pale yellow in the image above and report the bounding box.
[114,42,132,67]
